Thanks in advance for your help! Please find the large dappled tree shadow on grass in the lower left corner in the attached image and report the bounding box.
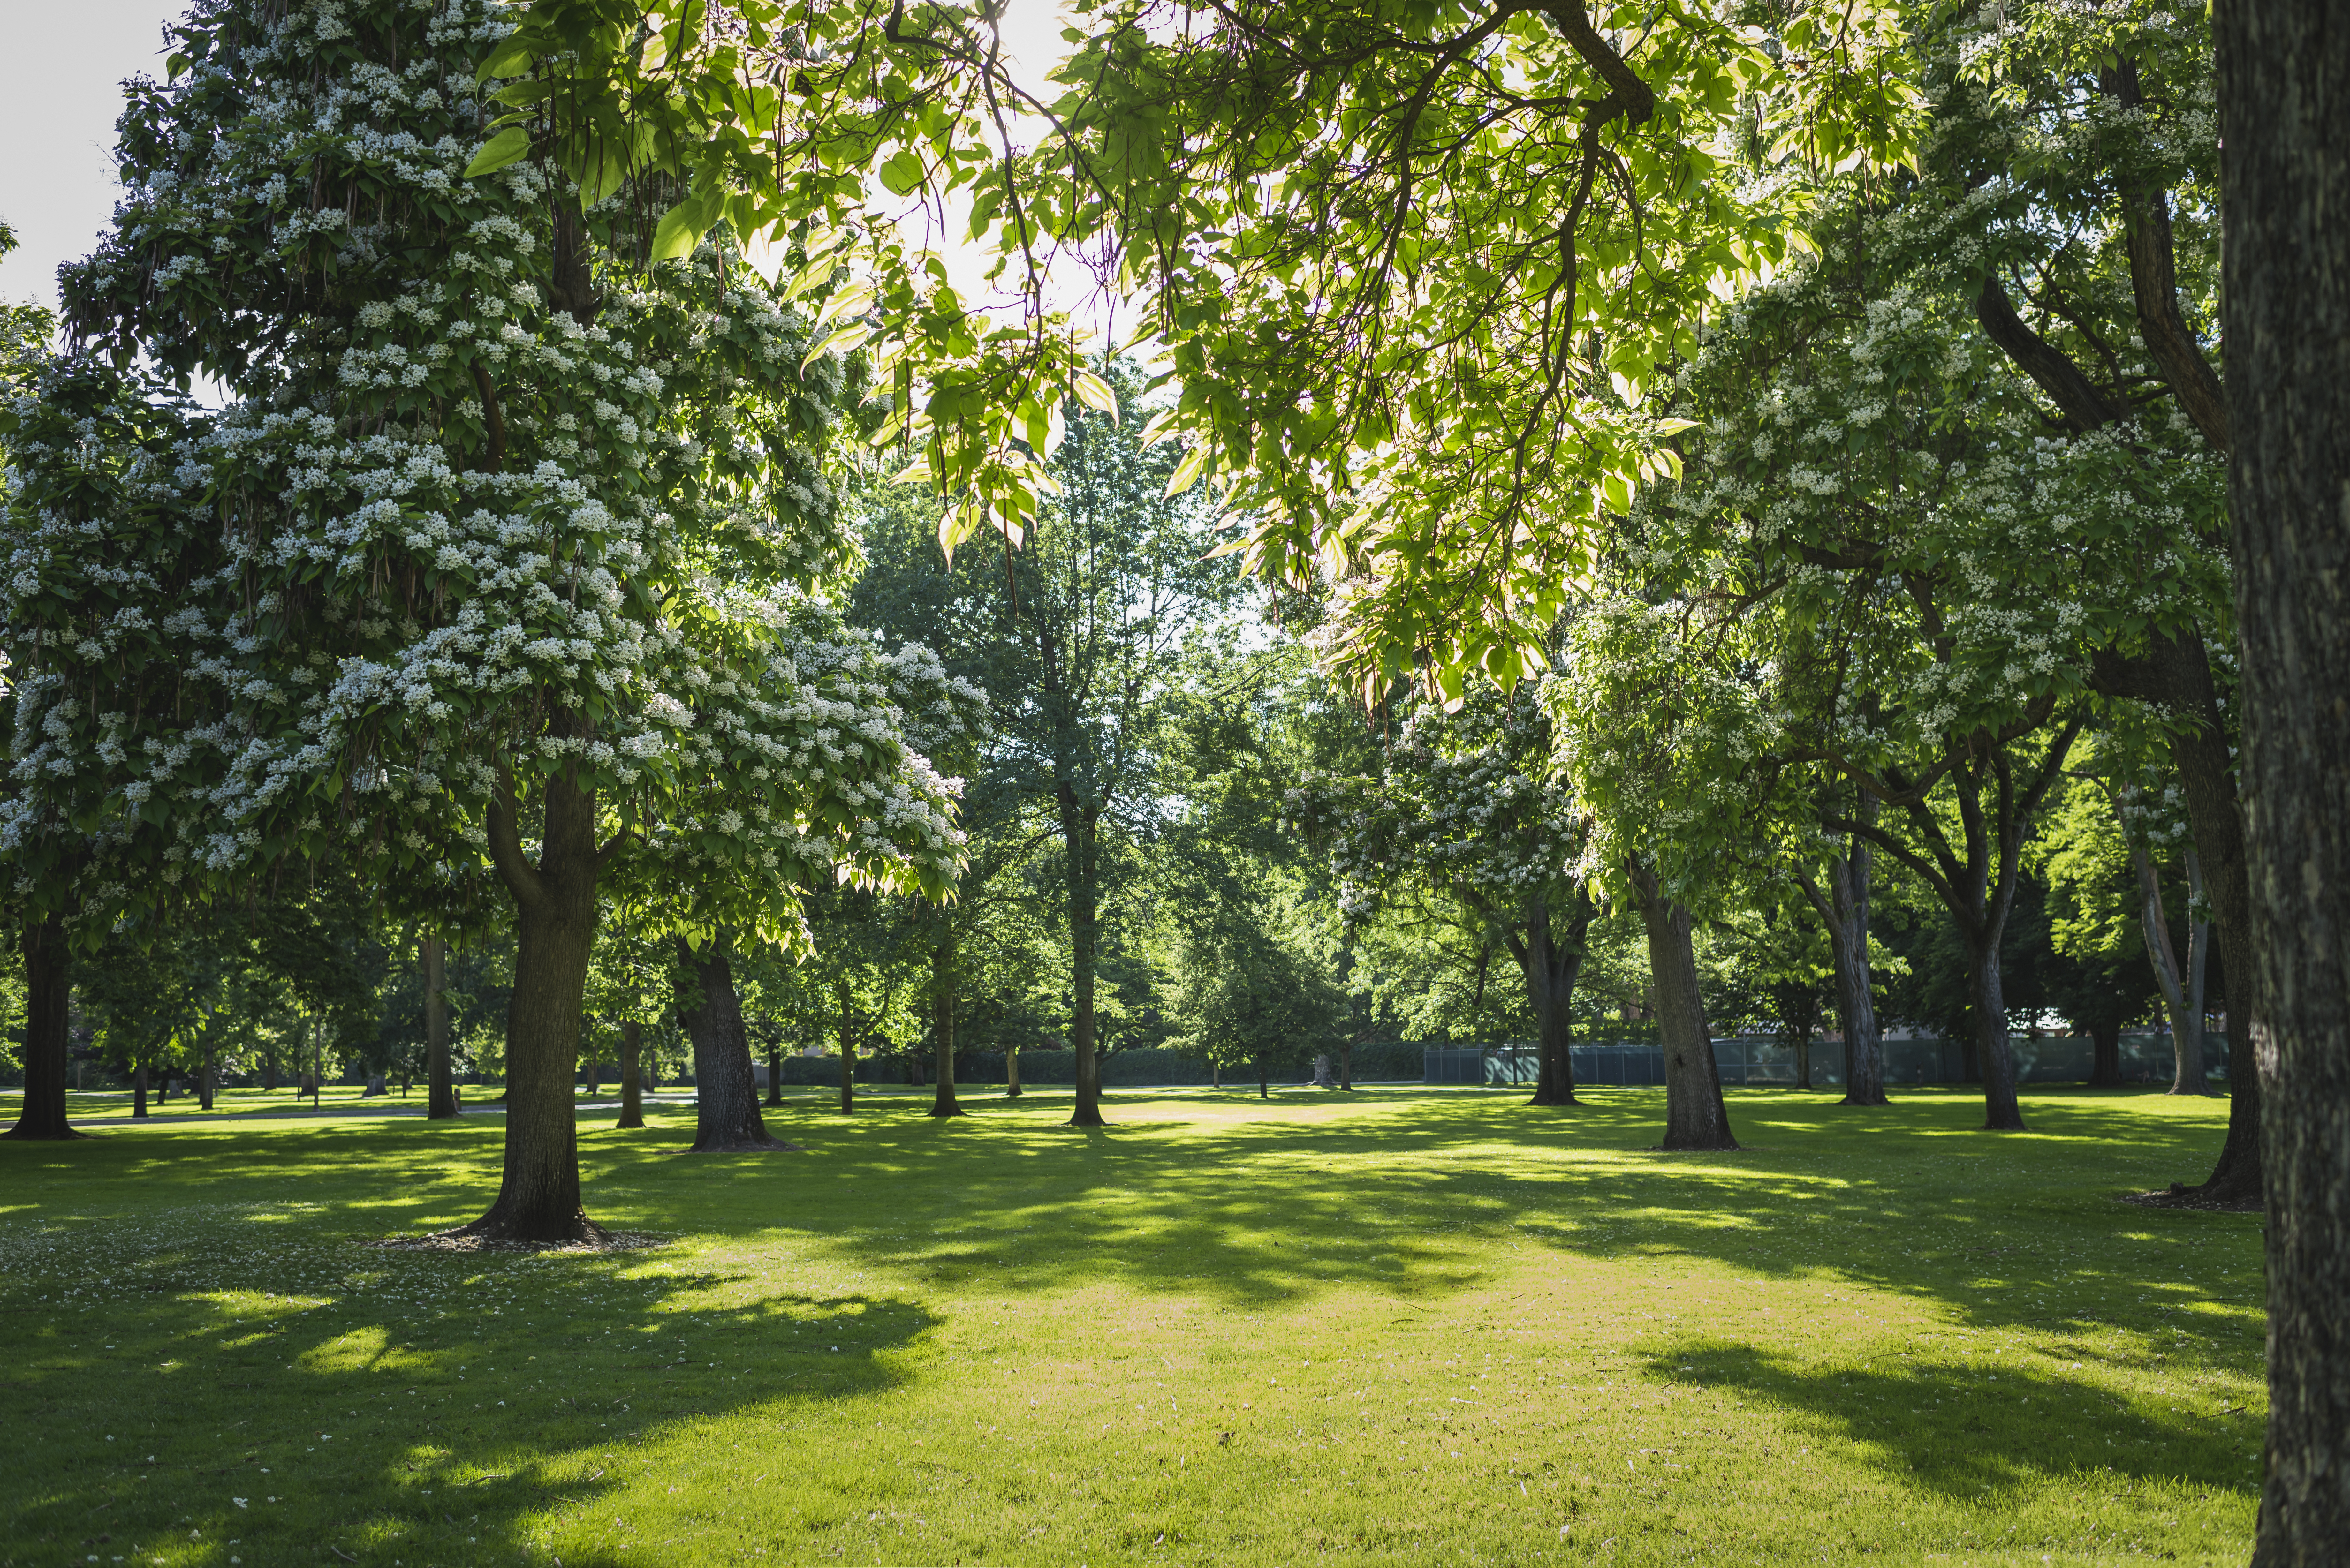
[0,1208,938,1568]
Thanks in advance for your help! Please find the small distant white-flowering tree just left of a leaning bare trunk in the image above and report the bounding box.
[1288,682,1598,1105]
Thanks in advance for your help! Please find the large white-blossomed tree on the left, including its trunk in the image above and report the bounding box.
[7,0,957,1239]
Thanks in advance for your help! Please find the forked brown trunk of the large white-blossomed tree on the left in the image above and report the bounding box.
[461,773,604,1241]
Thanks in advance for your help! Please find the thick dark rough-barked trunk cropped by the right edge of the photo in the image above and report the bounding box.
[2197,0,2350,1568]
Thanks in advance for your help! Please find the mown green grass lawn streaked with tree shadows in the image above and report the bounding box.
[0,1089,2263,1568]
